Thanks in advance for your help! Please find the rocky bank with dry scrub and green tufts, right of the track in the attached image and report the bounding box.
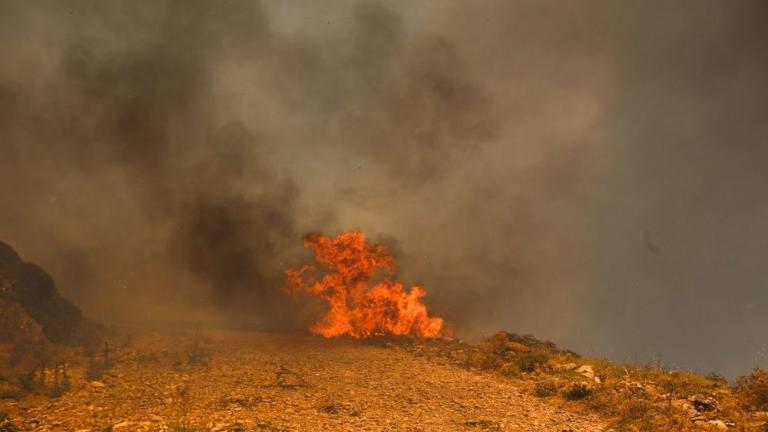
[401,332,768,432]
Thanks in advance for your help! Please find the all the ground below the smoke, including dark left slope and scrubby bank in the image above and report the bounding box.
[0,243,768,432]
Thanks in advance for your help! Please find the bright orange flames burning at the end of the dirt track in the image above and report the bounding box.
[285,231,443,338]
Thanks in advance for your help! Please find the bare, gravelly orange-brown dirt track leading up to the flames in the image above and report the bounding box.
[0,330,603,432]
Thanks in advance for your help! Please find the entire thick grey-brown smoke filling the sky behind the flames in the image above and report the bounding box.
[0,0,768,375]
